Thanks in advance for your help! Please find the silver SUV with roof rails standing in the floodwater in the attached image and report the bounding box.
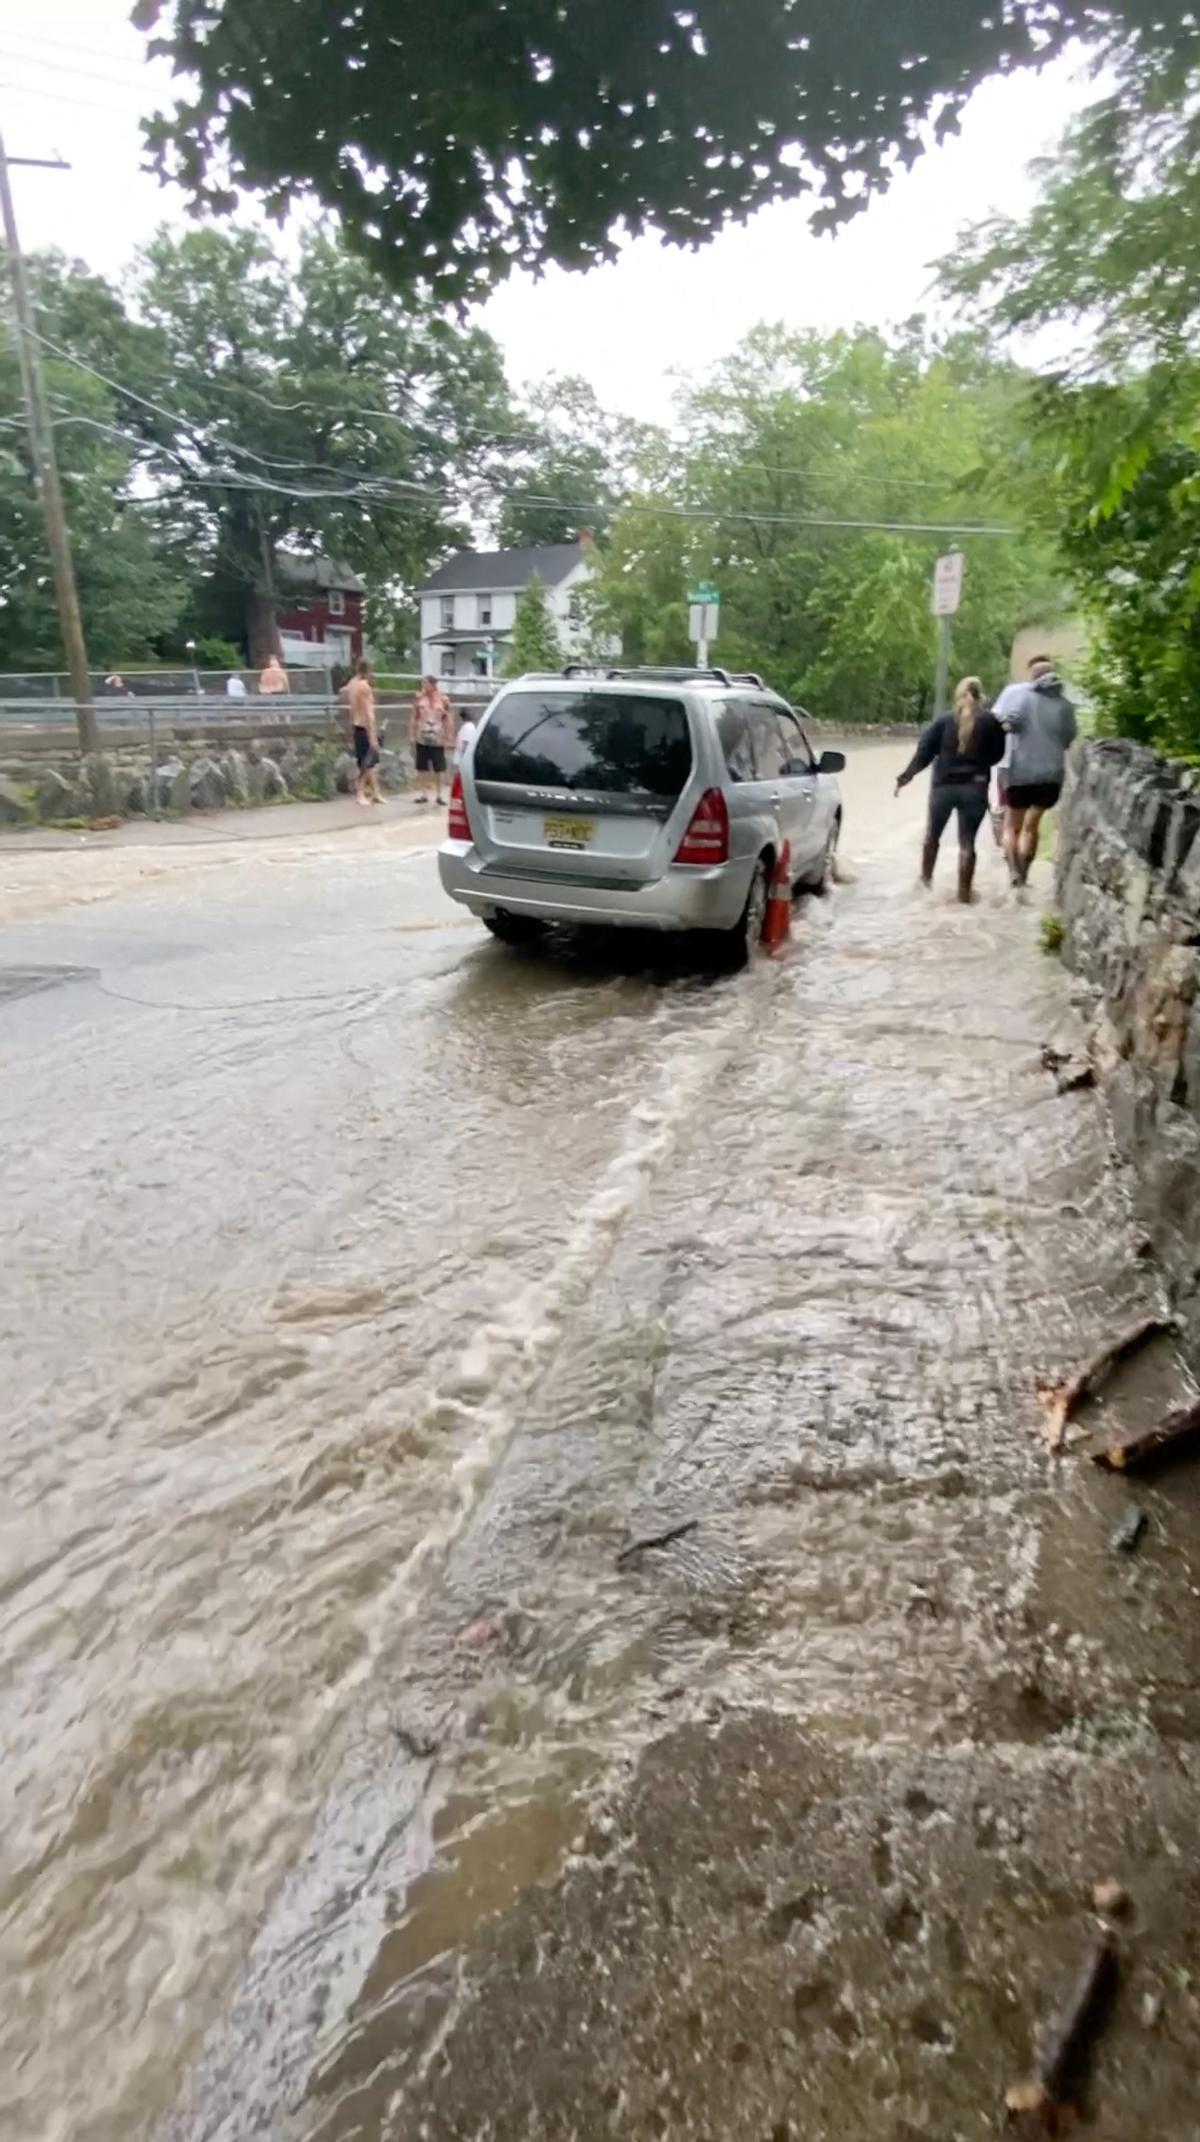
[437,668,846,966]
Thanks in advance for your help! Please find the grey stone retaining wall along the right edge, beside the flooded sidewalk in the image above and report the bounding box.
[1056,739,1200,1345]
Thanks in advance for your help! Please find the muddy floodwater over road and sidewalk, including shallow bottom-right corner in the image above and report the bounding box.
[0,743,1200,2142]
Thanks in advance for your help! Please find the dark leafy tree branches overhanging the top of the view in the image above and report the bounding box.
[135,0,1189,302]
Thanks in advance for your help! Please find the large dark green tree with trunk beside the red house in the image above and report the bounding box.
[124,229,510,662]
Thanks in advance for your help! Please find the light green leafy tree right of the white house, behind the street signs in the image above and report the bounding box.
[617,321,1054,720]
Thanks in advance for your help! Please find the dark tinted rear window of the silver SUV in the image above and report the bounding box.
[474,690,692,797]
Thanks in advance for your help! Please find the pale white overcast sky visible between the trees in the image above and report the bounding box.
[0,0,1089,418]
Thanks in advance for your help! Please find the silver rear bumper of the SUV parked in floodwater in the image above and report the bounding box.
[437,840,750,930]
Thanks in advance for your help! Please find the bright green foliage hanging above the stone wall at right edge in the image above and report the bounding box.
[943,33,1200,754]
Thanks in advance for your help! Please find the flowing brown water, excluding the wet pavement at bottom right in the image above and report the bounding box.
[0,745,1200,2142]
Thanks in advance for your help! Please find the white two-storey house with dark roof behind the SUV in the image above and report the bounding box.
[418,533,594,677]
